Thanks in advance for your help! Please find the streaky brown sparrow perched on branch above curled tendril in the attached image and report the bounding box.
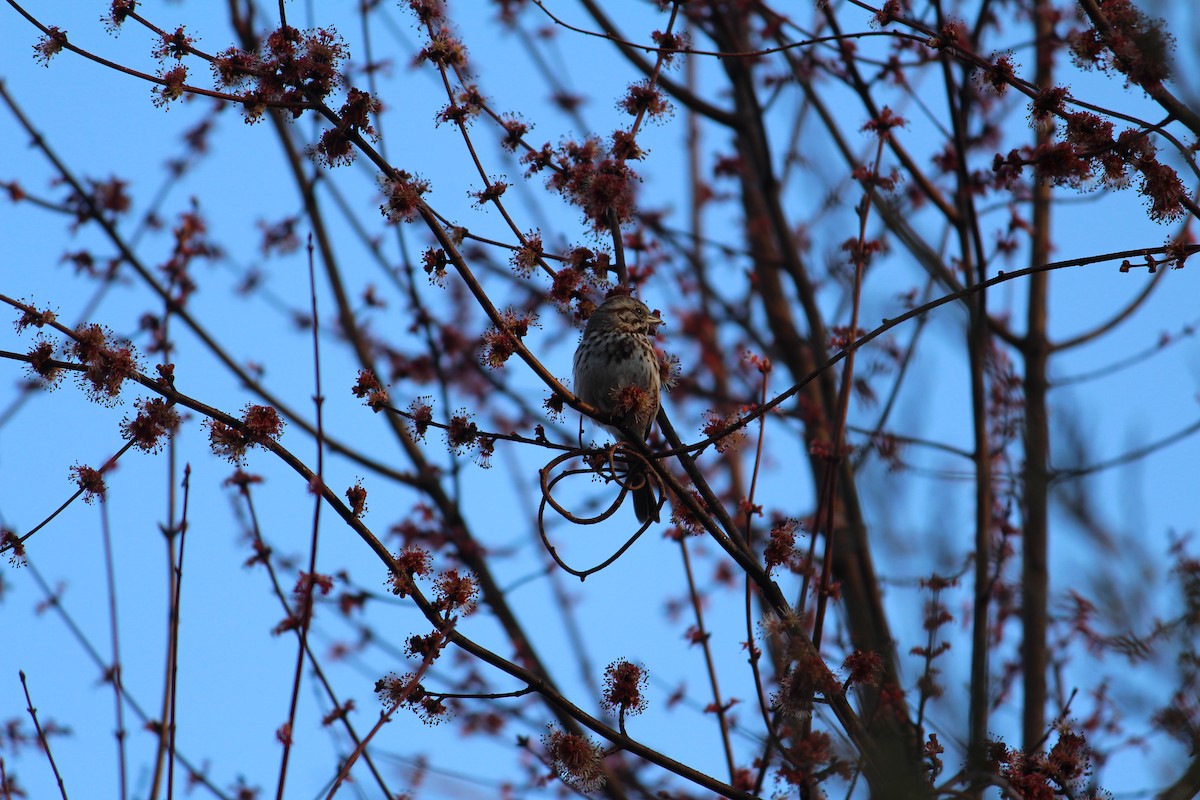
[575,294,662,522]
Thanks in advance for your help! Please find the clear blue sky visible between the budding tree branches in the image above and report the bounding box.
[0,0,1200,798]
